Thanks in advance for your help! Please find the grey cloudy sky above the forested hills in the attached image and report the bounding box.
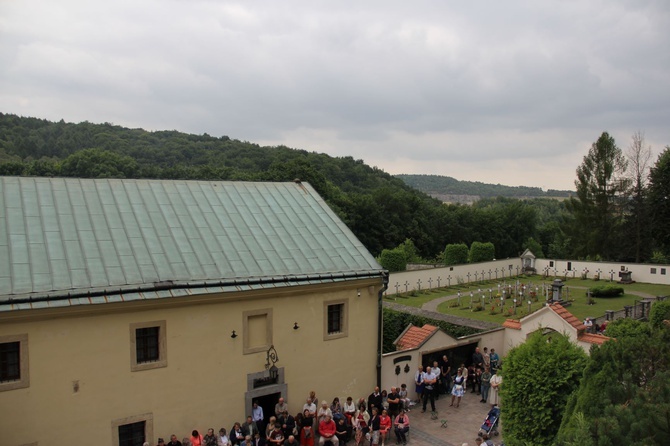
[0,0,670,189]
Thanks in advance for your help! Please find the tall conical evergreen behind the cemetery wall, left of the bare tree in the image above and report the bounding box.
[566,132,629,260]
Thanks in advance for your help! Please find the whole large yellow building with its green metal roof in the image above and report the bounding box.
[0,177,387,446]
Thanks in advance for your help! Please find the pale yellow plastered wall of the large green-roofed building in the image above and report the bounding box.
[0,280,381,445]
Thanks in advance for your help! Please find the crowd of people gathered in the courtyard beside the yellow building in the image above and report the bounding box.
[150,347,502,446]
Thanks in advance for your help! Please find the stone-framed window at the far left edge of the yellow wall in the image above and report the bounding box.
[0,334,30,392]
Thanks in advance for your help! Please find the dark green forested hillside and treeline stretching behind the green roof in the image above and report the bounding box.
[0,113,670,262]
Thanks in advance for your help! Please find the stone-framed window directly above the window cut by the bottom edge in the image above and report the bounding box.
[130,321,167,372]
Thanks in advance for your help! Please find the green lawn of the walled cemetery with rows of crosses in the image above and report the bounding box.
[386,276,670,324]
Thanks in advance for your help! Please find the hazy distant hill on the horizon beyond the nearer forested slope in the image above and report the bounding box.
[395,174,573,203]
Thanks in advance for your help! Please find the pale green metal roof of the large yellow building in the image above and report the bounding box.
[0,177,383,309]
